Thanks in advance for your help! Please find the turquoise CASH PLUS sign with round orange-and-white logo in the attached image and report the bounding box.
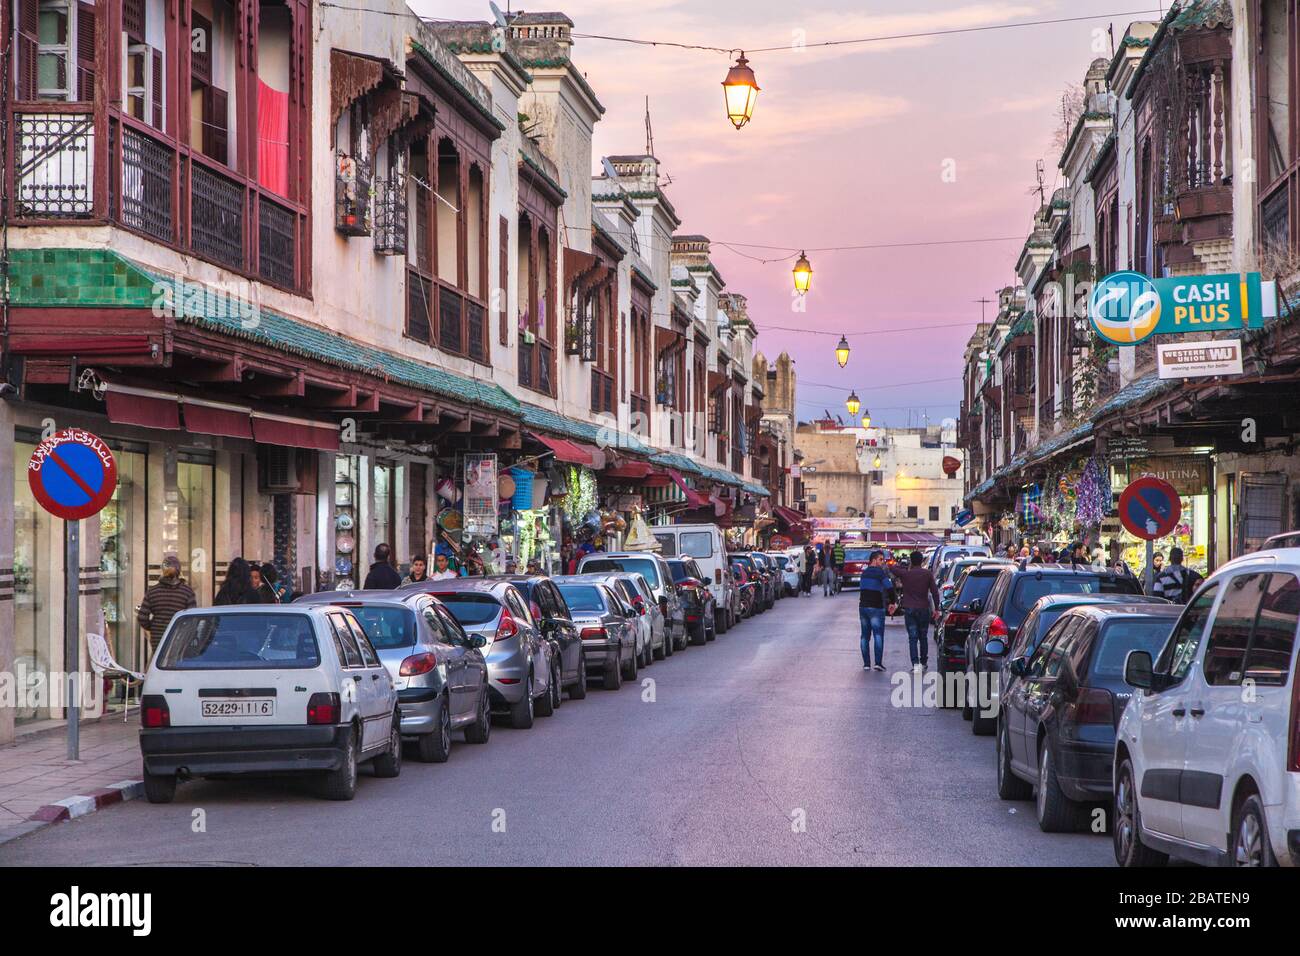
[1088,271,1277,345]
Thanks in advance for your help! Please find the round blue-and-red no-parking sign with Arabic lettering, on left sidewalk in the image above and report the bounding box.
[27,428,117,522]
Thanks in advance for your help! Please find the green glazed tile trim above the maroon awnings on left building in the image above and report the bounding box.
[10,248,520,415]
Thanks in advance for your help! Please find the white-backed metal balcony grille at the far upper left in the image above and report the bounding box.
[14,113,95,219]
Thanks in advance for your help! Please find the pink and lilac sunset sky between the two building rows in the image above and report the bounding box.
[413,0,1160,425]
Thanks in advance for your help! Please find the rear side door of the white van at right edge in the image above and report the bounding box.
[1179,571,1296,849]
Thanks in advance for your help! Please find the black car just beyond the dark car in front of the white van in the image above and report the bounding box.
[962,564,1141,736]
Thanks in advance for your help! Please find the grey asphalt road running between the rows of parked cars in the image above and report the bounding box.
[0,594,1114,866]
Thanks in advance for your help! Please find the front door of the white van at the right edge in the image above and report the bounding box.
[1134,581,1219,839]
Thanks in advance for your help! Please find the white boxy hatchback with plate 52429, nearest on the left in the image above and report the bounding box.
[140,605,402,804]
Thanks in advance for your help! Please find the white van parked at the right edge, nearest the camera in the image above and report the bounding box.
[1113,548,1300,866]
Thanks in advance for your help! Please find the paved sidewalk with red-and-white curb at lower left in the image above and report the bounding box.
[0,714,142,843]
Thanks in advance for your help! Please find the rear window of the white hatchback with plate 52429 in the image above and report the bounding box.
[159,613,321,670]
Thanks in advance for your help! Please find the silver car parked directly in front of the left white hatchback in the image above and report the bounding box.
[294,591,491,763]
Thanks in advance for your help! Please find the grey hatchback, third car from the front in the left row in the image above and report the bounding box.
[408,578,560,730]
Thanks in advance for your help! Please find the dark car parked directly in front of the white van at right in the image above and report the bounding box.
[997,604,1183,832]
